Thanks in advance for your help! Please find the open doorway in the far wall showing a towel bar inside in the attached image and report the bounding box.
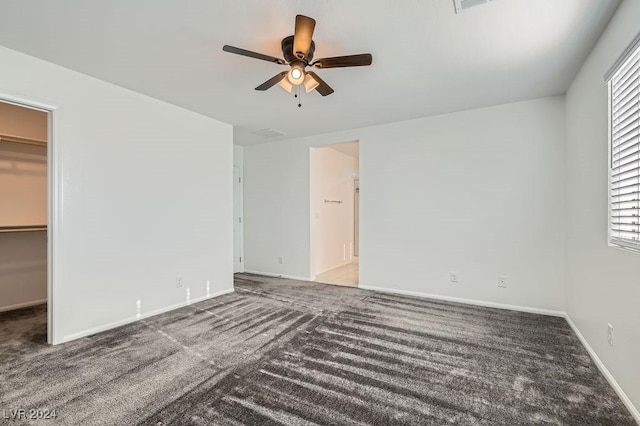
[311,141,360,287]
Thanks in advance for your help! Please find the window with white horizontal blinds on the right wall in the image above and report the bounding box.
[607,36,640,250]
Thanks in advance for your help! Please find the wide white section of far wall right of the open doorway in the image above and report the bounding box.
[360,97,565,311]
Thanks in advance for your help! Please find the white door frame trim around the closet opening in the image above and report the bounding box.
[0,93,63,345]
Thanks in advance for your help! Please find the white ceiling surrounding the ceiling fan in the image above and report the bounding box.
[0,0,619,145]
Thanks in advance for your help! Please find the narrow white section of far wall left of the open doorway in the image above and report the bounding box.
[243,140,312,279]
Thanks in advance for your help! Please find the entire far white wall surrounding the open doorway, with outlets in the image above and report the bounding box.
[244,97,565,311]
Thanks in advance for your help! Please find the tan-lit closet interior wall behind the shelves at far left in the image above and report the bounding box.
[0,102,47,311]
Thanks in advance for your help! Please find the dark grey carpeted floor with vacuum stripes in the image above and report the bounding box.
[0,274,635,425]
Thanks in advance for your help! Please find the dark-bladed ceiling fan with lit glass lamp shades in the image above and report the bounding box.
[222,15,373,96]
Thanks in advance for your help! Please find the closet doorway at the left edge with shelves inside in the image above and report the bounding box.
[0,98,53,343]
